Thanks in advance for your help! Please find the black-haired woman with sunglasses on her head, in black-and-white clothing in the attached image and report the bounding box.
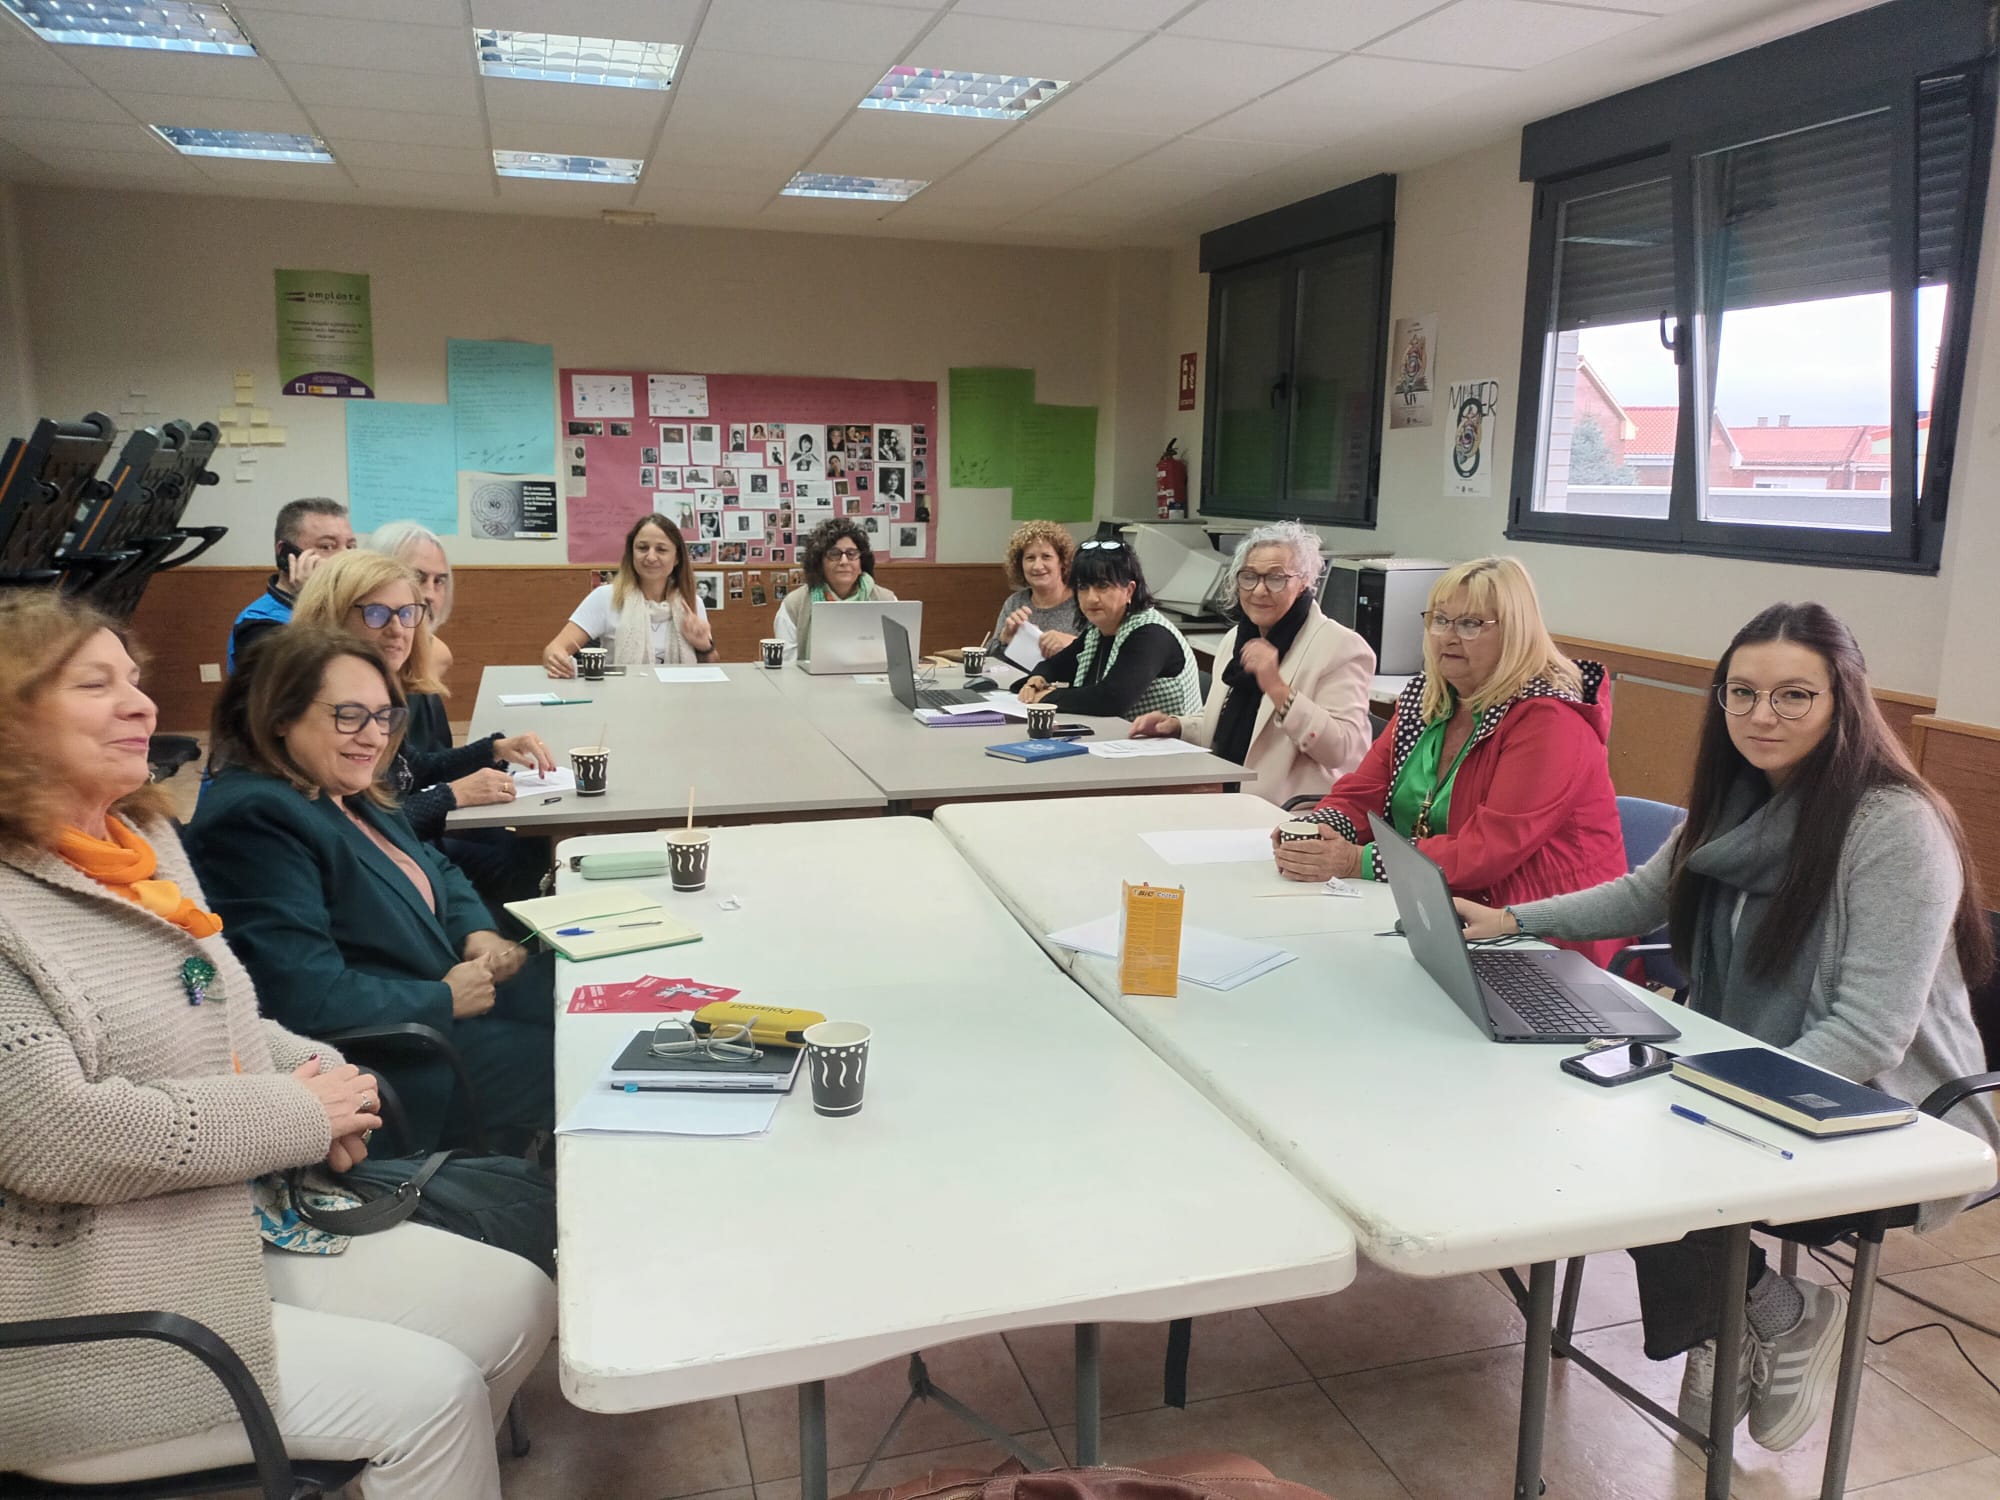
[1020,540,1202,718]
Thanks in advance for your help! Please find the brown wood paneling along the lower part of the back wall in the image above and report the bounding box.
[132,562,1008,734]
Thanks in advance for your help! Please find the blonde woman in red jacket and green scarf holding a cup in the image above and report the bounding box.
[1274,558,1626,964]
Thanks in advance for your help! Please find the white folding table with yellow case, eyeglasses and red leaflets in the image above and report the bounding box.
[556,818,1354,1500]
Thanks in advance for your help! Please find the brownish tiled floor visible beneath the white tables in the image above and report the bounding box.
[460,1204,2000,1500]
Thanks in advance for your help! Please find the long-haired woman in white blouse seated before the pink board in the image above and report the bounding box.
[542,516,716,678]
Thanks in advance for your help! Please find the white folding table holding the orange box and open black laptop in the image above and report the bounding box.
[936,796,1994,1500]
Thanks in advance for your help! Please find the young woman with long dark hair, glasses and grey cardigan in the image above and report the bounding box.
[1458,604,2000,1448]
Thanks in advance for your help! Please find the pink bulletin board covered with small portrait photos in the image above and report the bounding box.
[560,370,938,568]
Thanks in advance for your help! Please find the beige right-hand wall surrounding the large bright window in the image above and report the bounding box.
[1172,136,2000,700]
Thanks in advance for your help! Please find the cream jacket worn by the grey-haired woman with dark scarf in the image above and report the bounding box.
[1180,604,1374,808]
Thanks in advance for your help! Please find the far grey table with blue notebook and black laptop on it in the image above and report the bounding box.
[770,666,1256,812]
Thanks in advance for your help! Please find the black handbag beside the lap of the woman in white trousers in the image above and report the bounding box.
[292,1152,556,1278]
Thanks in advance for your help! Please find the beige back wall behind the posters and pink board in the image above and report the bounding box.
[11,190,1172,564]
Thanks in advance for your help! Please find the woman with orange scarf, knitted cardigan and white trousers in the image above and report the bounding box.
[0,592,554,1500]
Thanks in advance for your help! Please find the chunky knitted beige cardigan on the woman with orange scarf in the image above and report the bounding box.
[0,822,336,1470]
